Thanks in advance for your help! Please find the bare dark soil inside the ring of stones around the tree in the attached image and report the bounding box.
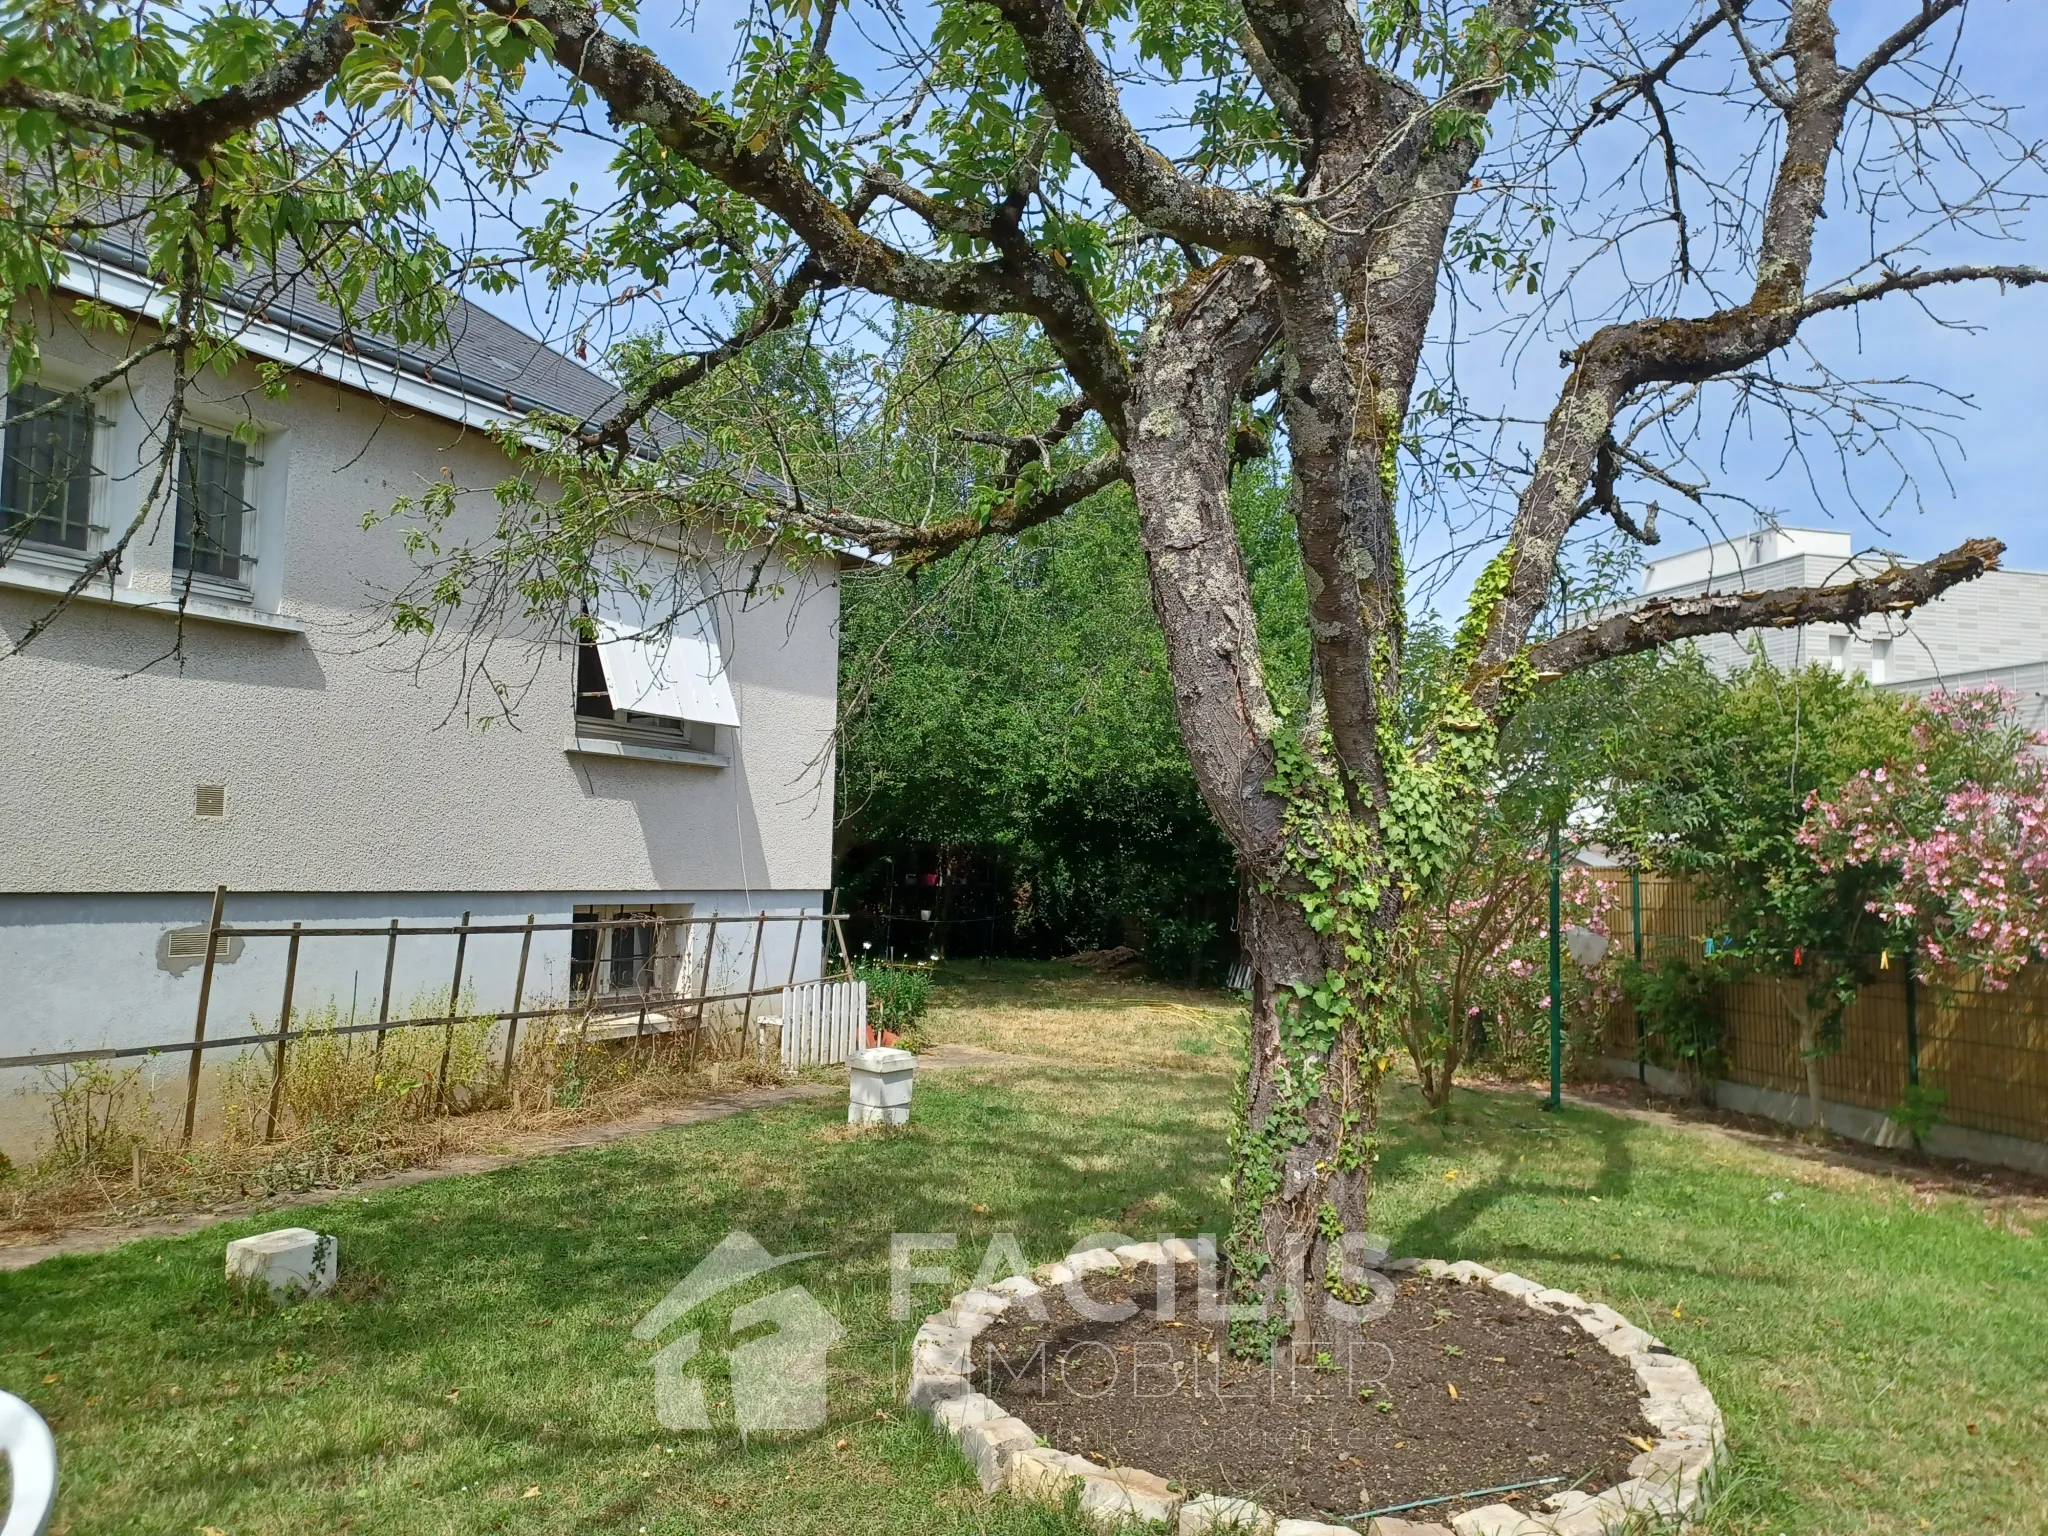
[973,1266,1657,1522]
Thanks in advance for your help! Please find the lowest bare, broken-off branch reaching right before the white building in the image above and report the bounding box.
[1528,539,2005,678]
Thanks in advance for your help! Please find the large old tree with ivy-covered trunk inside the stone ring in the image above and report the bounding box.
[0,0,2023,1350]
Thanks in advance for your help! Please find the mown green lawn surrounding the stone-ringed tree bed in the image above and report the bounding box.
[0,975,2048,1536]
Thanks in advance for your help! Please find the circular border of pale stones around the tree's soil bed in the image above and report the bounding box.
[907,1237,1726,1536]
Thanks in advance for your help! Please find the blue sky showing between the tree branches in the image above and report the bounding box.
[456,0,2048,604]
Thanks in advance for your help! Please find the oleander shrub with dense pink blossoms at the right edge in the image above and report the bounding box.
[1798,688,2048,989]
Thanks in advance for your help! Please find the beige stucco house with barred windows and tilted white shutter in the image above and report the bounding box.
[0,246,838,1147]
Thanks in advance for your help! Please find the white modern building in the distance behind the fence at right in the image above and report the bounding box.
[1642,528,2048,729]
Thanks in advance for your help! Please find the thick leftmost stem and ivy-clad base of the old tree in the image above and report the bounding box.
[1128,262,1380,1352]
